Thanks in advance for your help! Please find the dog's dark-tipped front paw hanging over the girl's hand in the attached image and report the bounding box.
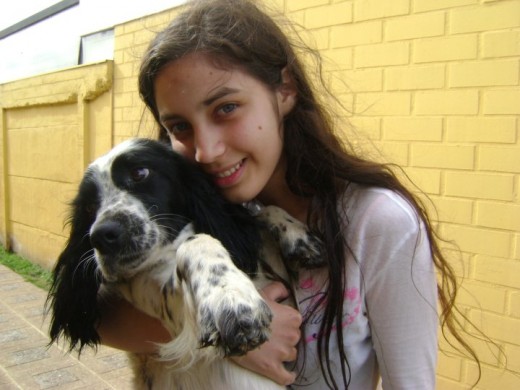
[199,282,272,356]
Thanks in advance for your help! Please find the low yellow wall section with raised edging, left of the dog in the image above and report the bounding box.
[0,62,113,268]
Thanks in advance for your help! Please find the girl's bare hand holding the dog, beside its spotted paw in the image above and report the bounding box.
[232,282,302,385]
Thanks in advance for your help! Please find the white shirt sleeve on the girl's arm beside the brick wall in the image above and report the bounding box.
[351,191,438,390]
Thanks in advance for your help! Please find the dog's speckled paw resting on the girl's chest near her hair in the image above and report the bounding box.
[258,206,325,270]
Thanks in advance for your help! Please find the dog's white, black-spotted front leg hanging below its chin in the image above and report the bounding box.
[177,234,272,356]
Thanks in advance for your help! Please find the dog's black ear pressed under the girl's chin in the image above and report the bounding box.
[175,155,261,275]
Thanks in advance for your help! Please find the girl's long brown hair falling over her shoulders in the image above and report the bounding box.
[139,0,478,388]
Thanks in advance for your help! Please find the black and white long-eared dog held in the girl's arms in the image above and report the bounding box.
[48,139,321,390]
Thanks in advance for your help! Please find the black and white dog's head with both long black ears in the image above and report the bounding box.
[48,139,260,350]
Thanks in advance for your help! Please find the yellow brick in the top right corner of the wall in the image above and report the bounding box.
[450,1,520,34]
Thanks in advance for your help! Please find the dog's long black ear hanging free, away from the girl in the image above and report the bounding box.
[46,174,101,352]
